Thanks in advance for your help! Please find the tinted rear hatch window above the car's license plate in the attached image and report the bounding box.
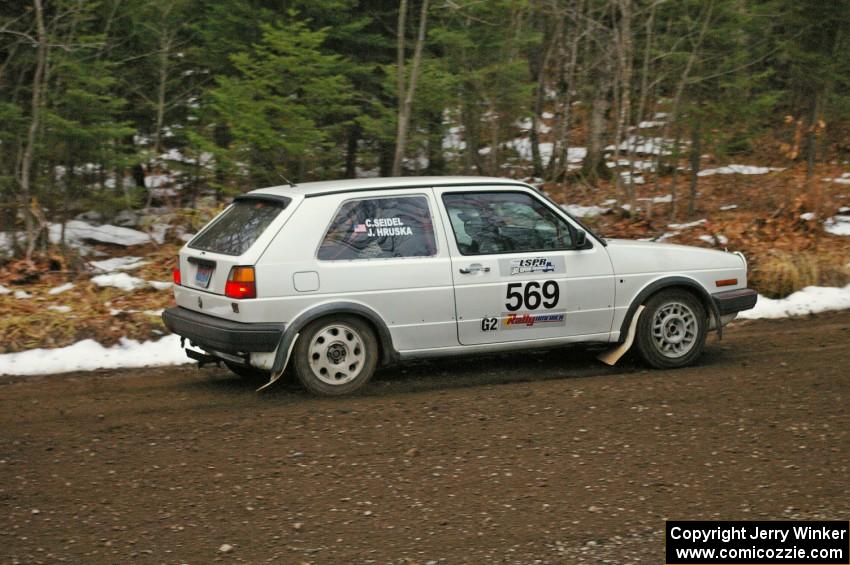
[189,199,287,255]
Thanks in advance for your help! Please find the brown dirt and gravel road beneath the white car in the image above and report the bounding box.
[0,313,850,564]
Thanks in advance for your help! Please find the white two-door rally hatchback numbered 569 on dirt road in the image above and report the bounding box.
[163,177,756,395]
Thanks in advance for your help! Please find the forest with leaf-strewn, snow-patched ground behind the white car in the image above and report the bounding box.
[0,0,850,351]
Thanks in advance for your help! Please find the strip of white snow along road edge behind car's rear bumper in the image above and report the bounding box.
[0,335,191,375]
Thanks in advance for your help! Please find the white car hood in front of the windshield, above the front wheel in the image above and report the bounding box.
[606,239,746,274]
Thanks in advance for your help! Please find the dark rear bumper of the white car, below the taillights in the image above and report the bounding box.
[162,306,284,354]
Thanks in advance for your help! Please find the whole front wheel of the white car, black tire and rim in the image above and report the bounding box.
[635,289,708,369]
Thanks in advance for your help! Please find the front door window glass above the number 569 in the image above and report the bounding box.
[443,192,572,255]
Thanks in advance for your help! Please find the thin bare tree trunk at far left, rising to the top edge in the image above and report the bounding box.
[19,0,47,261]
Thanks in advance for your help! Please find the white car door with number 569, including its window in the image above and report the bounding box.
[437,187,614,345]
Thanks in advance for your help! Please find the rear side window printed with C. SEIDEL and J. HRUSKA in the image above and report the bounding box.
[318,196,437,261]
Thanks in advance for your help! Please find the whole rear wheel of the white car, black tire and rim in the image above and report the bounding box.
[292,316,379,396]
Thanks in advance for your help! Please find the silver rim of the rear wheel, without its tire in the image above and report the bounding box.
[308,324,366,385]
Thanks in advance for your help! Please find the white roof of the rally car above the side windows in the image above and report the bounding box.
[249,176,533,198]
